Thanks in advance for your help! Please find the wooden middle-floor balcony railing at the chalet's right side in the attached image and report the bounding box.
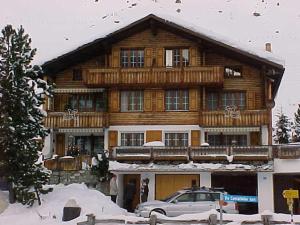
[199,110,269,127]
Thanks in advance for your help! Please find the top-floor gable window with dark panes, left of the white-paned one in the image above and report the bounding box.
[121,49,144,68]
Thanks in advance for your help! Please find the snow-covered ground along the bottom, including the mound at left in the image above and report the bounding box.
[0,184,300,225]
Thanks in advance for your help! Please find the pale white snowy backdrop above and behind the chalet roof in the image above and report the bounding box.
[0,0,300,119]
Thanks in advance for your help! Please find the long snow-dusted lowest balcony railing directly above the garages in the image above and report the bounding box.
[111,146,273,162]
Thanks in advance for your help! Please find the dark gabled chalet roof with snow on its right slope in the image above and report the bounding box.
[42,14,284,93]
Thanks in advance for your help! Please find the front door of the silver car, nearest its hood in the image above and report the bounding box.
[166,193,195,216]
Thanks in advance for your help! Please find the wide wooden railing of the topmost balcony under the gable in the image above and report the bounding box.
[84,66,224,87]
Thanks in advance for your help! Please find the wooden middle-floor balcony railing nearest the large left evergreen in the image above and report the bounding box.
[45,112,109,128]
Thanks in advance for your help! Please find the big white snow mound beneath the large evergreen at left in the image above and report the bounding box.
[0,184,127,225]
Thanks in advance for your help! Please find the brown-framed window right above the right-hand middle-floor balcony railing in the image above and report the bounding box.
[222,92,246,109]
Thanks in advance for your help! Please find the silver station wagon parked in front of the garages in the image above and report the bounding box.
[135,188,239,217]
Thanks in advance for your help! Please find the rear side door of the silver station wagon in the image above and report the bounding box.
[193,192,216,212]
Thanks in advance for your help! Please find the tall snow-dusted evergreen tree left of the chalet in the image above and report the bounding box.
[0,25,52,205]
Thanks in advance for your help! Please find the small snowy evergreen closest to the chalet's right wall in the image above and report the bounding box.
[274,112,291,144]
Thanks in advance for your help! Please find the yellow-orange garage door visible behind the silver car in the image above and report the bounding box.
[155,174,200,200]
